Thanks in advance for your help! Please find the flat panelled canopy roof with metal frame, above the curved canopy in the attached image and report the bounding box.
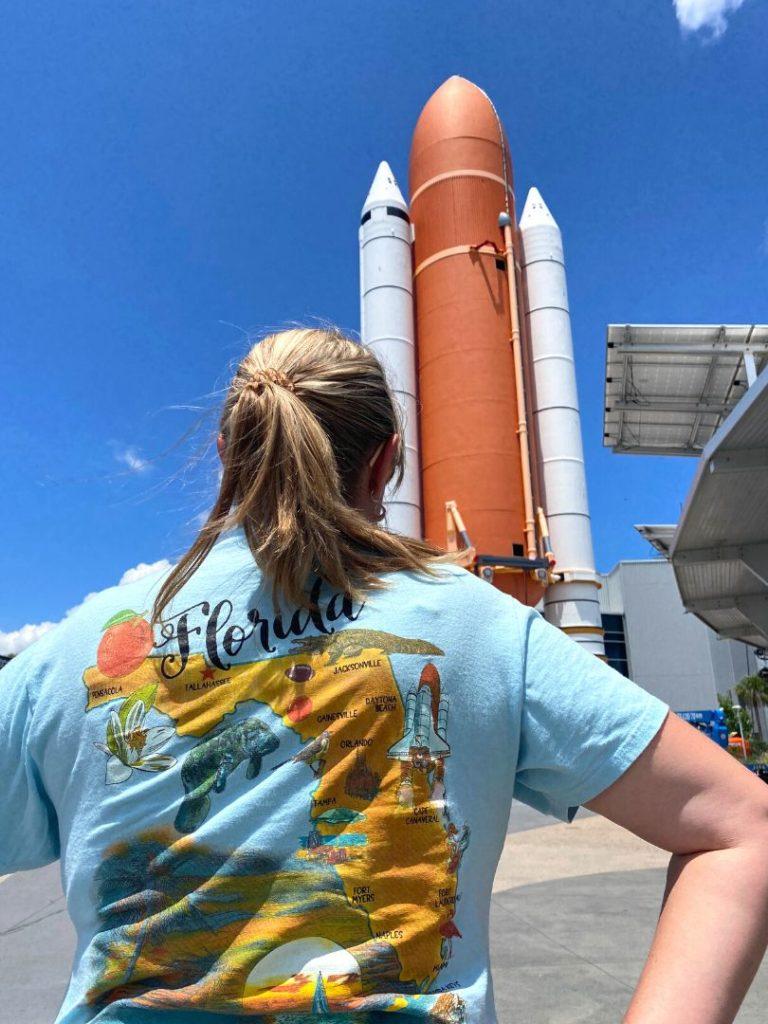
[603,324,768,456]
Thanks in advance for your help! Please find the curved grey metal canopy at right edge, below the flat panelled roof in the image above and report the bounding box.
[670,370,768,647]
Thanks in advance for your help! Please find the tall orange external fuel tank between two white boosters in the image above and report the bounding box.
[410,77,543,604]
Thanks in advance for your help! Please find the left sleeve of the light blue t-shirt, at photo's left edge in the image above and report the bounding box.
[0,652,59,874]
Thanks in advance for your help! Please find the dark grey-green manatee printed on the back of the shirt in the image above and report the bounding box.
[175,715,280,833]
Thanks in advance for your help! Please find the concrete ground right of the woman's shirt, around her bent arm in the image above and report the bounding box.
[490,808,768,1024]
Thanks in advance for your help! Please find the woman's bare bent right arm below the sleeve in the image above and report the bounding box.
[586,714,768,1024]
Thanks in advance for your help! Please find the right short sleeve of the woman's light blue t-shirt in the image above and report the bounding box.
[514,610,670,821]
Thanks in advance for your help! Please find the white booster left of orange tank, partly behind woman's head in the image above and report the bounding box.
[359,161,422,538]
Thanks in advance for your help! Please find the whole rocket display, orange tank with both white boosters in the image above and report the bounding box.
[360,76,603,655]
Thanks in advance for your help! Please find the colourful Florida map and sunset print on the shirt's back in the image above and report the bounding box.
[83,604,470,1024]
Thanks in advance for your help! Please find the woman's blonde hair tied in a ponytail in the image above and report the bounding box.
[153,328,447,622]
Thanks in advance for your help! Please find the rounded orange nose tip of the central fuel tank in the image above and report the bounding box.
[411,75,511,196]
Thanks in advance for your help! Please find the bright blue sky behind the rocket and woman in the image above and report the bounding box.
[0,0,768,633]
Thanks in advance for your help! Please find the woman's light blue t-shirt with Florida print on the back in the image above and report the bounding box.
[0,530,669,1024]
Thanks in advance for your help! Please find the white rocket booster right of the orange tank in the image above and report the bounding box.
[520,188,604,656]
